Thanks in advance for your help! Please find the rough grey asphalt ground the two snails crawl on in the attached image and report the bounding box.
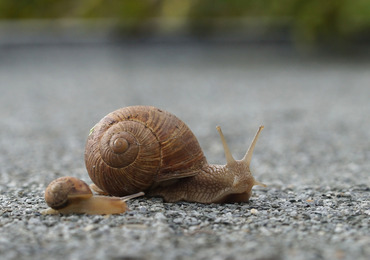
[0,44,370,260]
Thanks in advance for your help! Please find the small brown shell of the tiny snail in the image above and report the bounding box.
[45,176,93,209]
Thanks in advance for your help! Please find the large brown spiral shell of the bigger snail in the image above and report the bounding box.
[85,106,207,196]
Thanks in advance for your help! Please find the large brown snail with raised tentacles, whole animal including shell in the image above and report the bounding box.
[85,106,266,203]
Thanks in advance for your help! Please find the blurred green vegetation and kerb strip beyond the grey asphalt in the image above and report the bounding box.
[0,0,370,49]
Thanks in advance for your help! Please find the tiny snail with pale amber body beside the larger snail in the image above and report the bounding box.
[41,176,144,215]
